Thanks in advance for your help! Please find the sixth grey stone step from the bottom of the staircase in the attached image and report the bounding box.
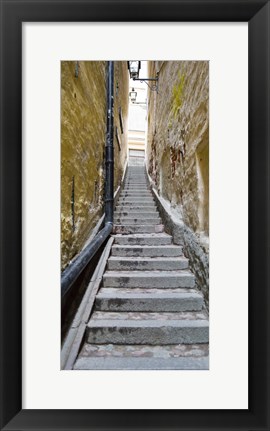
[111,245,183,257]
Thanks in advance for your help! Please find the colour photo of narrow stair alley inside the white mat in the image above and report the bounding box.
[61,60,209,370]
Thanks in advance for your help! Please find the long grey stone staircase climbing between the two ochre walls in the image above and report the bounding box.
[74,166,209,369]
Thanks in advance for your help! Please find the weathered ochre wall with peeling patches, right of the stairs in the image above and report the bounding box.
[146,61,209,299]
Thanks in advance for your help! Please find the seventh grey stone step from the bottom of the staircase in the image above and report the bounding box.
[114,233,172,246]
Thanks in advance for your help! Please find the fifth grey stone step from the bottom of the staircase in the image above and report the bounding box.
[107,256,188,271]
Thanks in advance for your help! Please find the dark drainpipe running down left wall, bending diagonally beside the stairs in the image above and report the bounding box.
[61,61,114,298]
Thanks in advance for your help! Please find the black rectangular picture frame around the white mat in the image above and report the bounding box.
[0,0,270,431]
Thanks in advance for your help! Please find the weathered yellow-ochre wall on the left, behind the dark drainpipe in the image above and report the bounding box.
[61,61,128,269]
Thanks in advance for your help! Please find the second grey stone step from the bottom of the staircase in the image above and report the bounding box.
[86,312,209,345]
